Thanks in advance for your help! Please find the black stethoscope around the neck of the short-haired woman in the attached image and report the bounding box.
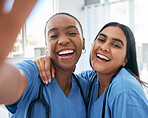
[27,73,85,118]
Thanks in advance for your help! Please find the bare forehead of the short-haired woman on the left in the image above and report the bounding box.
[46,14,81,31]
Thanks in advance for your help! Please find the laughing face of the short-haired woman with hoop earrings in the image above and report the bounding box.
[46,14,84,71]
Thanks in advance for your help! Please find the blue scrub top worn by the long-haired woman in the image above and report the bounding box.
[79,68,148,118]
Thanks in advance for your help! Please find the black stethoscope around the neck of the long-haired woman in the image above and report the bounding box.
[86,68,121,118]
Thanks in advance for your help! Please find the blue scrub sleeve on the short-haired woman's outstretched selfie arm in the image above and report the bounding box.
[6,60,41,118]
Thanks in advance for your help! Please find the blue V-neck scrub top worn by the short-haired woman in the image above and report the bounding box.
[6,60,89,118]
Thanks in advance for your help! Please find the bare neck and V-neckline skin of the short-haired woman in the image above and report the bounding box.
[55,69,72,96]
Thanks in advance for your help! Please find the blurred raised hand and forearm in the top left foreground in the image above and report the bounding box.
[0,0,37,66]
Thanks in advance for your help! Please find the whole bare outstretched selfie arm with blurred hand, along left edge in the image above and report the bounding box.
[0,0,37,105]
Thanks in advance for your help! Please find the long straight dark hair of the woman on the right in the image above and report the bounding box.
[90,22,148,88]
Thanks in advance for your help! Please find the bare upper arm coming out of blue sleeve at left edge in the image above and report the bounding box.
[0,62,28,105]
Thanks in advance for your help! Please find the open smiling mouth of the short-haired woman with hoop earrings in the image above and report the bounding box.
[57,49,75,60]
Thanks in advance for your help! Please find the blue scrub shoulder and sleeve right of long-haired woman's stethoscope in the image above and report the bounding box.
[107,68,148,118]
